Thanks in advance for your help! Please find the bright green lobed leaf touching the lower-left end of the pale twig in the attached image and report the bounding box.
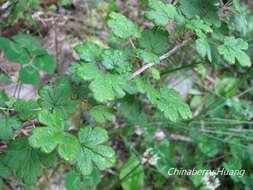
[89,74,126,102]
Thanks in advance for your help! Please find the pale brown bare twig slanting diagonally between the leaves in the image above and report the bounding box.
[129,38,192,80]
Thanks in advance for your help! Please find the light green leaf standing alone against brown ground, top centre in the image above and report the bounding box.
[107,12,141,39]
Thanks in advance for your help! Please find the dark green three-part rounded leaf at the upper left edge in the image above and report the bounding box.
[0,34,56,85]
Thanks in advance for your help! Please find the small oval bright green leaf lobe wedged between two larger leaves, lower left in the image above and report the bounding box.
[58,133,80,163]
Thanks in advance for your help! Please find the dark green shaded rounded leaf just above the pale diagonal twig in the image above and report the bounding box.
[139,30,169,55]
